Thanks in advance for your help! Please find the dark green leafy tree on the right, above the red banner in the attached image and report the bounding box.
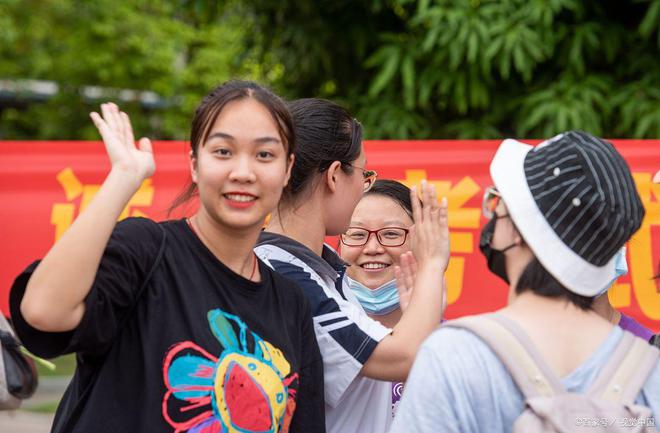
[241,0,660,138]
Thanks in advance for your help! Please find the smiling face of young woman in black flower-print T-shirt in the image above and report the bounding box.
[191,98,292,229]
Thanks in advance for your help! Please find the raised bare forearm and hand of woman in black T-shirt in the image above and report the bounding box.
[21,103,155,332]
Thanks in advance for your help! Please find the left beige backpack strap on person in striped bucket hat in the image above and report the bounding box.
[442,313,565,399]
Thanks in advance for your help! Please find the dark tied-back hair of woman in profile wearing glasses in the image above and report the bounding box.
[282,98,362,203]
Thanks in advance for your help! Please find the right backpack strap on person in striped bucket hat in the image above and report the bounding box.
[588,331,660,404]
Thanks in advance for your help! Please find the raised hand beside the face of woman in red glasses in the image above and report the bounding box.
[410,181,449,272]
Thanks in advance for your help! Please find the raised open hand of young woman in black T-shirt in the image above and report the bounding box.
[90,103,156,186]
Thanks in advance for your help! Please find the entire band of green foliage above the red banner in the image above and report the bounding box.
[0,0,660,139]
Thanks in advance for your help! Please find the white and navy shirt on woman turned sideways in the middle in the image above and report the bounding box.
[255,232,392,433]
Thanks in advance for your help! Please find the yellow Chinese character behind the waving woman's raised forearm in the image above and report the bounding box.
[50,167,154,241]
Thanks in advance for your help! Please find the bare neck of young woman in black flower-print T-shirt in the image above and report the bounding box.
[190,209,260,279]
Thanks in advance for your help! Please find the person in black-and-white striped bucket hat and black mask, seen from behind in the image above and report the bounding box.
[391,131,660,433]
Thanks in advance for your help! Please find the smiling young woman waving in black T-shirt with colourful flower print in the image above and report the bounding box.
[10,81,325,433]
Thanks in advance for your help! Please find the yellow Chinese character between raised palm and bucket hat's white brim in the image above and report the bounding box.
[401,170,481,305]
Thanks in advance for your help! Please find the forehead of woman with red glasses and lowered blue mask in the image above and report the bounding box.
[351,194,412,227]
